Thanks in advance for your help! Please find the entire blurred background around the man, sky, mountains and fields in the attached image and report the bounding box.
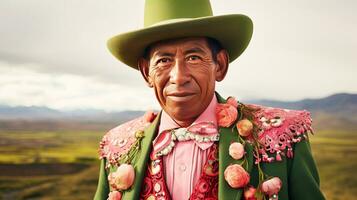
[0,0,357,200]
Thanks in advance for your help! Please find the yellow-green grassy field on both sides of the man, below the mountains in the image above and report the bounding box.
[0,130,357,200]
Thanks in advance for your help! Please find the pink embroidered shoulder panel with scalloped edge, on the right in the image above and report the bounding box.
[248,104,313,162]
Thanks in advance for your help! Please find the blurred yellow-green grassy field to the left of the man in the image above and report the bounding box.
[0,131,103,200]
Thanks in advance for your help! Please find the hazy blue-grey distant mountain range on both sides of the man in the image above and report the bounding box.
[0,93,357,130]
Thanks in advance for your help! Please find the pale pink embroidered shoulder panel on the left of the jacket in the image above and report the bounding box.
[99,111,156,164]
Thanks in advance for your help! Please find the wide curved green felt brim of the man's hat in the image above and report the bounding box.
[107,14,253,69]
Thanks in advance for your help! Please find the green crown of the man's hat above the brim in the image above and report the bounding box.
[144,0,213,27]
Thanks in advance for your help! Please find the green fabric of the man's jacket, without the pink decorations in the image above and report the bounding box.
[94,97,325,200]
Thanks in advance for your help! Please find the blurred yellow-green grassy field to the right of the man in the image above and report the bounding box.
[311,130,357,200]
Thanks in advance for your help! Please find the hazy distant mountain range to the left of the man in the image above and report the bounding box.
[0,106,144,131]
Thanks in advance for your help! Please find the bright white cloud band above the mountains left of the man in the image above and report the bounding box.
[0,62,158,111]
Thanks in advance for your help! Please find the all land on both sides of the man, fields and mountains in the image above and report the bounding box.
[0,94,357,200]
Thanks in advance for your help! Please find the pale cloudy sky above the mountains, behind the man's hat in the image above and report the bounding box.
[0,0,357,111]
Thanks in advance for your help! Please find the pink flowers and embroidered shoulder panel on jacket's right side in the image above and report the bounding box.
[216,97,312,200]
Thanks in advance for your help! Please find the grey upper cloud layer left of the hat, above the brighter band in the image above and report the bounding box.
[0,0,143,85]
